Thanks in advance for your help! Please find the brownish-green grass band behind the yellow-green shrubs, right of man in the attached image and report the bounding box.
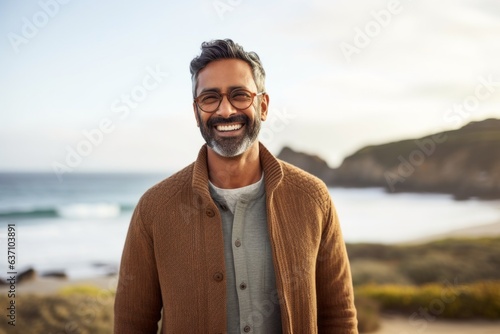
[347,237,500,285]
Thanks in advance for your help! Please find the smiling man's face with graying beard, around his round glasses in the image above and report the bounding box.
[193,59,269,157]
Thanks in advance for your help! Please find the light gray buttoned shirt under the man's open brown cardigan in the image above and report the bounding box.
[210,176,281,334]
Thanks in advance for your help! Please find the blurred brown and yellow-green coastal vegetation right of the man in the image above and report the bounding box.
[347,237,500,333]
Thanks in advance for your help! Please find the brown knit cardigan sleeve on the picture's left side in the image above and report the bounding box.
[114,202,162,334]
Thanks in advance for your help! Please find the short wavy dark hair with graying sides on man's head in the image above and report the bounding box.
[189,39,266,98]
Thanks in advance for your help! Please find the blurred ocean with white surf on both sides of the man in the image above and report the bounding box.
[0,173,500,278]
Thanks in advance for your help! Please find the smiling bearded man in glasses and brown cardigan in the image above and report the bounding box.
[115,40,357,334]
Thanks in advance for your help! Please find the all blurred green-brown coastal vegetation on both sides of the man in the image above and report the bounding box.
[0,237,500,334]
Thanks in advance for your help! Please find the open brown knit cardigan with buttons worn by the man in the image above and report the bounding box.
[114,145,357,334]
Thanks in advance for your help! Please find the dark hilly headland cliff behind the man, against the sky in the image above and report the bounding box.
[278,119,500,199]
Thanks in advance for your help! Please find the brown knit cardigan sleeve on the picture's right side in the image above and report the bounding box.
[316,199,358,334]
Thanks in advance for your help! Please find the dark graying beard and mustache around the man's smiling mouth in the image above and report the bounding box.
[198,110,262,158]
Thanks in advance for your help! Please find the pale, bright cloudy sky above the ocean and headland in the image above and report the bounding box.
[0,0,500,175]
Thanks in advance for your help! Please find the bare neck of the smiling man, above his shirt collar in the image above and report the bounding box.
[207,142,262,189]
